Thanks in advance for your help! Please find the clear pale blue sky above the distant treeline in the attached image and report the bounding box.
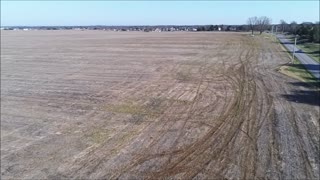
[1,0,319,26]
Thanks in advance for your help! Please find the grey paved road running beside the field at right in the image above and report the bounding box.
[277,35,320,79]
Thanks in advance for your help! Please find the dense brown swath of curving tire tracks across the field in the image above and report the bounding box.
[108,35,273,179]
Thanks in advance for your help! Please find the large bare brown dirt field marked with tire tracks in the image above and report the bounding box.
[1,31,320,179]
